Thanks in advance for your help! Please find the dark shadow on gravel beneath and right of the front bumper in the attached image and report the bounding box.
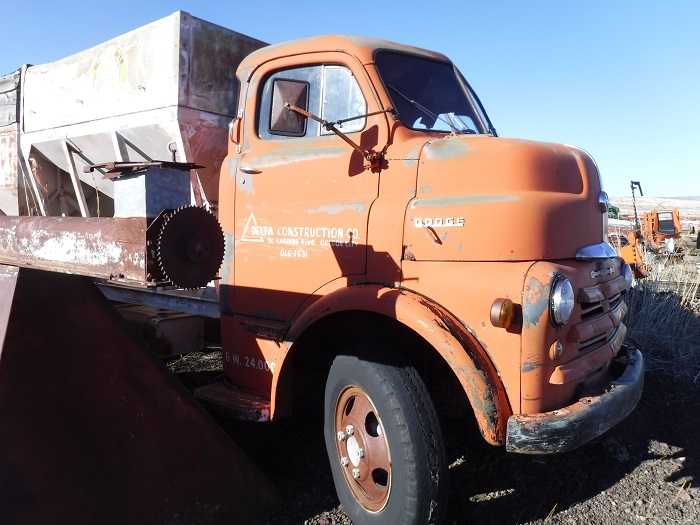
[447,375,700,524]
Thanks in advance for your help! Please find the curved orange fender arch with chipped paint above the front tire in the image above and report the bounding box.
[285,285,512,445]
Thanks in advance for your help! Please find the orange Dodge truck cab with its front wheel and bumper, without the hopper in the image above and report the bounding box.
[3,9,643,524]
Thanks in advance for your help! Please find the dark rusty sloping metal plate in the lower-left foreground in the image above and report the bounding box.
[0,265,279,524]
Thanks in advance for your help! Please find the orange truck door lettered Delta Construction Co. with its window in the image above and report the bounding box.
[231,56,386,321]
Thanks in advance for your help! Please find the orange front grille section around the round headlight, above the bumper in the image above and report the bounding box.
[521,258,627,414]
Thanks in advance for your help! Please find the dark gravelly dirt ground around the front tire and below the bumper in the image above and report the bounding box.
[176,364,700,525]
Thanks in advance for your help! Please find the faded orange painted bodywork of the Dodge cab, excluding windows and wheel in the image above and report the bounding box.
[220,36,640,454]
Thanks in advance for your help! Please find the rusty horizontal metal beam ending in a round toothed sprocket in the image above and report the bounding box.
[0,207,224,287]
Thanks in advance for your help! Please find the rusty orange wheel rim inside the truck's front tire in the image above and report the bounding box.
[335,386,391,512]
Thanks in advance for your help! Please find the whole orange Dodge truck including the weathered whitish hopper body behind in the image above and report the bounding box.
[0,12,643,524]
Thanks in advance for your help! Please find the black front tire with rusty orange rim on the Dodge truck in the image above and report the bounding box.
[324,346,448,525]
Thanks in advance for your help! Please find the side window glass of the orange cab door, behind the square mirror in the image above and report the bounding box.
[257,65,367,140]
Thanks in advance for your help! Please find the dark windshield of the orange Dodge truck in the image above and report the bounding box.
[375,51,495,135]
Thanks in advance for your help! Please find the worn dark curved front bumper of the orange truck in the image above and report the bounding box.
[506,348,644,454]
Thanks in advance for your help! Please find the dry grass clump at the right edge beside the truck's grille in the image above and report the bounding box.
[626,239,700,384]
